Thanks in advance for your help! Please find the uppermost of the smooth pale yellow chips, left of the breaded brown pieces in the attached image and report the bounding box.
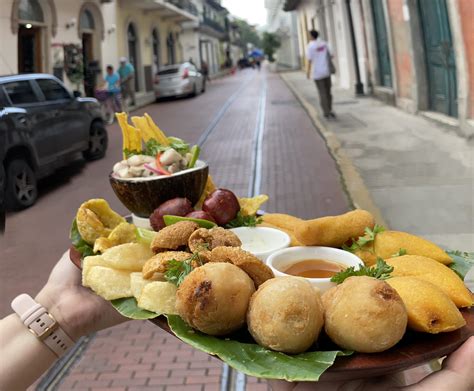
[102,243,153,272]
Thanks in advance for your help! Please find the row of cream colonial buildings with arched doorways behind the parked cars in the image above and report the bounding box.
[0,0,241,104]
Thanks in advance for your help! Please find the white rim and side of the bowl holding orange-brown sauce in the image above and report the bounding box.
[267,246,364,293]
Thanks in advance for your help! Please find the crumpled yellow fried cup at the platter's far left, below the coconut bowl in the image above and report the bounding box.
[76,198,125,244]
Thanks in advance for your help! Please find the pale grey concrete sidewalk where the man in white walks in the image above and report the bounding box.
[281,72,474,251]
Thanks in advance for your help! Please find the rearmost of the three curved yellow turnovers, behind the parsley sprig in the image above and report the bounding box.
[373,231,453,265]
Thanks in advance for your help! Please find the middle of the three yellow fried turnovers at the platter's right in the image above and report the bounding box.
[386,255,474,307]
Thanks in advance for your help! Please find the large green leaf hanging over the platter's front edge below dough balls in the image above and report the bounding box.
[167,315,352,381]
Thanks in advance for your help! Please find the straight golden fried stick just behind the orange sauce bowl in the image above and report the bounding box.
[294,209,375,247]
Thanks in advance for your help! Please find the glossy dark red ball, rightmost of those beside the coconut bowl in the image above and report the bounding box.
[202,189,240,225]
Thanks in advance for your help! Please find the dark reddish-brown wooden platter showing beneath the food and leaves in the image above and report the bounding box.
[69,247,474,381]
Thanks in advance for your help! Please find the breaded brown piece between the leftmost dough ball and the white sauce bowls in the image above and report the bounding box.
[210,246,274,288]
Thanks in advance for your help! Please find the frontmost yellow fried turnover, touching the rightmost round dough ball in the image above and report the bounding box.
[387,277,466,334]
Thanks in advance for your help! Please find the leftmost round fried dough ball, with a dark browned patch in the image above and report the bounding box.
[176,262,255,335]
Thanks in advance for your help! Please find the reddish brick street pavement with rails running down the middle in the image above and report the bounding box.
[0,70,351,391]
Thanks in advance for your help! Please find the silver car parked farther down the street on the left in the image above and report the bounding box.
[154,62,206,99]
